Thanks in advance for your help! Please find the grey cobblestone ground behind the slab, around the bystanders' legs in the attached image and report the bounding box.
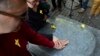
[49,0,100,29]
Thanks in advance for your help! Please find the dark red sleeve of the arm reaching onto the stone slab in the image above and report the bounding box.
[20,22,54,48]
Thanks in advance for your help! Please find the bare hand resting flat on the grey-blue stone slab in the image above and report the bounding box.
[53,36,69,49]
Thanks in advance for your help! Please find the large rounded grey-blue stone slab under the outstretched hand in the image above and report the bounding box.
[28,16,96,56]
